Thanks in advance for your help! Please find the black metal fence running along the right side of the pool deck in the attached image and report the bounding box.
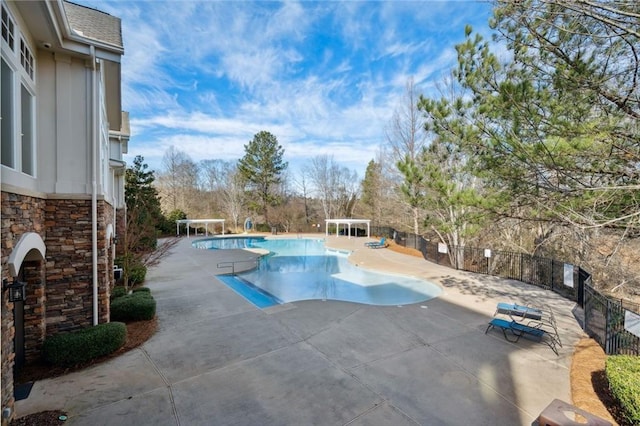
[371,227,640,355]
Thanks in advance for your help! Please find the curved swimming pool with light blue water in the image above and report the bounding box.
[193,237,441,307]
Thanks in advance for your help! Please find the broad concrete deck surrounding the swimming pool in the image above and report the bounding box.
[16,234,584,426]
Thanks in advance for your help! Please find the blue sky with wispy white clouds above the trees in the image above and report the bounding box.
[72,0,491,178]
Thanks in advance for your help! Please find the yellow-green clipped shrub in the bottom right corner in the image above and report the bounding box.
[605,355,640,425]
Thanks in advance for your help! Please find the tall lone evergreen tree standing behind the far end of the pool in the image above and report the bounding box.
[238,131,288,223]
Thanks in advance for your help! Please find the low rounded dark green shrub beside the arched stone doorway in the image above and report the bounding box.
[42,322,127,367]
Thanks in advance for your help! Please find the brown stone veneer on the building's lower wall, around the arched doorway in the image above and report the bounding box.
[0,192,115,425]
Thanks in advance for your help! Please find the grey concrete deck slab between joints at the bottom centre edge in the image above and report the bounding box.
[169,343,382,426]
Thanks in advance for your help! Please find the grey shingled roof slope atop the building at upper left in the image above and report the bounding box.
[62,1,123,49]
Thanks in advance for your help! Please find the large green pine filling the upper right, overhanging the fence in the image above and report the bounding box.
[456,0,640,231]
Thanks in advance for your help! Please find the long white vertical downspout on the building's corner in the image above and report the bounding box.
[89,45,100,326]
